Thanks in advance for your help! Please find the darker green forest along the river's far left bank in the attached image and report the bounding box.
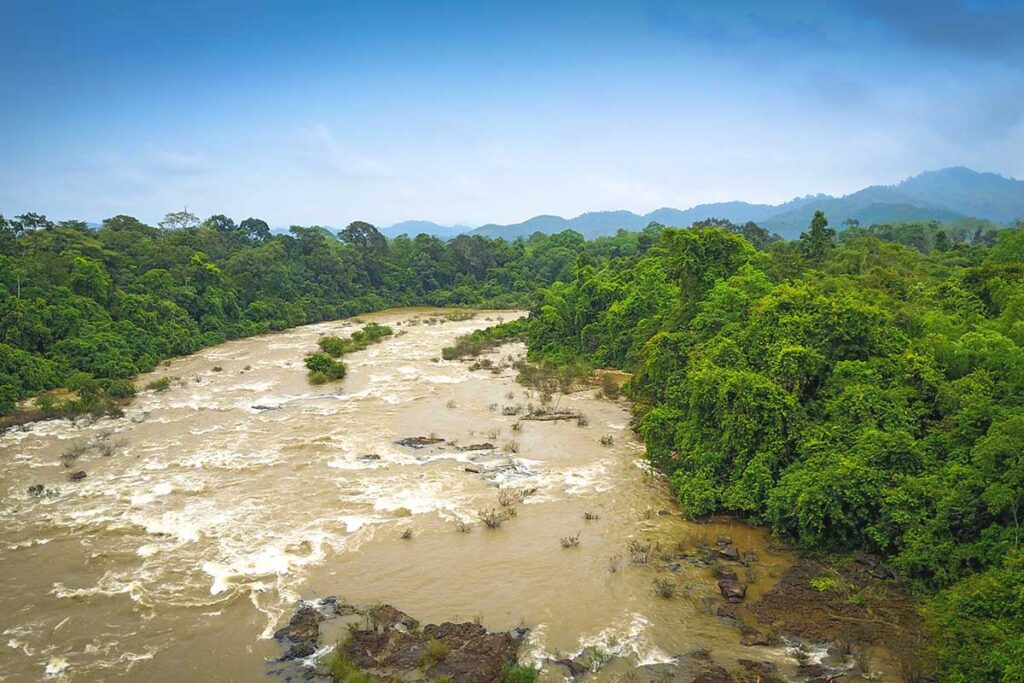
[0,213,639,413]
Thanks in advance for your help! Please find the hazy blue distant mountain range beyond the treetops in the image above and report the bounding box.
[381,167,1024,240]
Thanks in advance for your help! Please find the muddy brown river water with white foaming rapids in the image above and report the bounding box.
[0,309,839,683]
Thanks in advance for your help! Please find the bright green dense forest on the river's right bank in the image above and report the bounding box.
[512,213,1024,682]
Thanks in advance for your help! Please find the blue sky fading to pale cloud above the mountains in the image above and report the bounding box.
[0,0,1024,226]
